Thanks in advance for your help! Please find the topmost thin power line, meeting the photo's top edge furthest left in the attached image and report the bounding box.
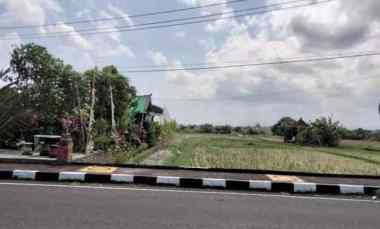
[0,0,248,30]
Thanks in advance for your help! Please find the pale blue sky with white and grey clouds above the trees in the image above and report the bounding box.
[0,0,380,129]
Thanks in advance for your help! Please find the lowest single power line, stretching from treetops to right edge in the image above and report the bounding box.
[119,52,380,73]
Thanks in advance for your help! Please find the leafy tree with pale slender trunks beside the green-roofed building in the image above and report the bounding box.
[84,66,136,151]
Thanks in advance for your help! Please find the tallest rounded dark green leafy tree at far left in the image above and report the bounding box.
[3,43,78,132]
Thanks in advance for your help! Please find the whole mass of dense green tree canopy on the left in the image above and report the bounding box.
[0,43,136,151]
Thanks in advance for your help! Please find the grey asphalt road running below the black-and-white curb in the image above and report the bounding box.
[0,183,380,229]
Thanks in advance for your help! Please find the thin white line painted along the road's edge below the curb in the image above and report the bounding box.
[0,182,380,204]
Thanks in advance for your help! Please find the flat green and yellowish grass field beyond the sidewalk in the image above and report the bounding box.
[146,134,380,175]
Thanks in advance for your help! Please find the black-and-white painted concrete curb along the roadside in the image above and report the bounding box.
[0,170,380,195]
